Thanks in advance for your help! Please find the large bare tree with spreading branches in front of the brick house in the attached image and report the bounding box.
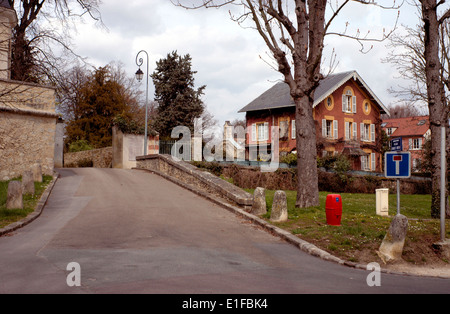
[175,0,396,208]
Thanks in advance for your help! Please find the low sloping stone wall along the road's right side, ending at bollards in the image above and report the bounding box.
[136,155,253,210]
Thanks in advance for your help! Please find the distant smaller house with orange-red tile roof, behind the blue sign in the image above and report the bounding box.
[381,116,431,170]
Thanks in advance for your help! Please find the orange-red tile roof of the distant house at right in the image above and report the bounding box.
[382,116,430,137]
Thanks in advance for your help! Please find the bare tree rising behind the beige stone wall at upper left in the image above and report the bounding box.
[8,0,101,83]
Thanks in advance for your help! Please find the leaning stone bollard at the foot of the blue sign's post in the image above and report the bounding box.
[377,214,408,264]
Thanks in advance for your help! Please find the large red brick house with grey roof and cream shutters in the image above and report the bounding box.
[239,71,389,171]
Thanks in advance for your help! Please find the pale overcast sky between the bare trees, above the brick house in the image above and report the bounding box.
[69,0,419,126]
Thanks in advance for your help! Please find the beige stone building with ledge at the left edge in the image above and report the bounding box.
[0,0,58,180]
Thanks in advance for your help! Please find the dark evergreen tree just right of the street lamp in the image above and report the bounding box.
[151,51,206,138]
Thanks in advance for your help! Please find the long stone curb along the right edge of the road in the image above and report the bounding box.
[133,168,448,279]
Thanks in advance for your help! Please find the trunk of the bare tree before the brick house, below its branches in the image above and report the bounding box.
[294,95,319,208]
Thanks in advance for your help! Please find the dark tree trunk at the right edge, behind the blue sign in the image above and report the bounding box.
[421,0,450,218]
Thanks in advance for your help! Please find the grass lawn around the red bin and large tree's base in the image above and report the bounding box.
[246,189,450,264]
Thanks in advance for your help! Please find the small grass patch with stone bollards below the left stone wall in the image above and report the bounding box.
[0,176,53,228]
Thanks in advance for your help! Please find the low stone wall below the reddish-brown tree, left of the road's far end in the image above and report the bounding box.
[64,147,113,168]
